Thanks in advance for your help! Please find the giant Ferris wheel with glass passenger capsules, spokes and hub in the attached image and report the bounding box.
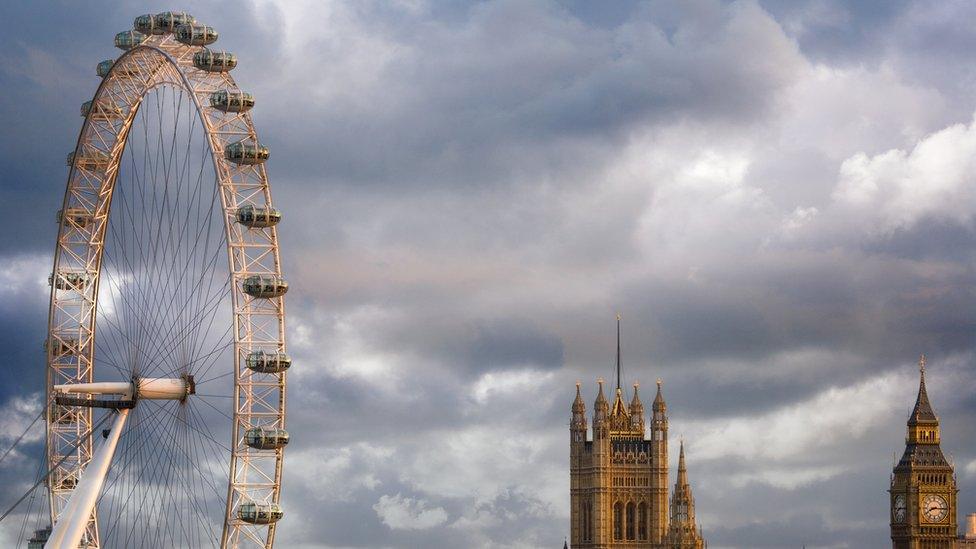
[43,12,291,549]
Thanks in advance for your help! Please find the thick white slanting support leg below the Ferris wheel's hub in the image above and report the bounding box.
[44,409,129,549]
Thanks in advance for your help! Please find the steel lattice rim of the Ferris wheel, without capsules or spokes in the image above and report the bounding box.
[46,17,287,547]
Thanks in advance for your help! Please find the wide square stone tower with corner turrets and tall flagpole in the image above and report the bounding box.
[569,317,704,549]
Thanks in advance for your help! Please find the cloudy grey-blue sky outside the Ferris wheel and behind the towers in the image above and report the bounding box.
[0,0,976,549]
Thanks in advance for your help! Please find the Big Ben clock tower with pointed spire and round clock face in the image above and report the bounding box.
[888,356,958,549]
